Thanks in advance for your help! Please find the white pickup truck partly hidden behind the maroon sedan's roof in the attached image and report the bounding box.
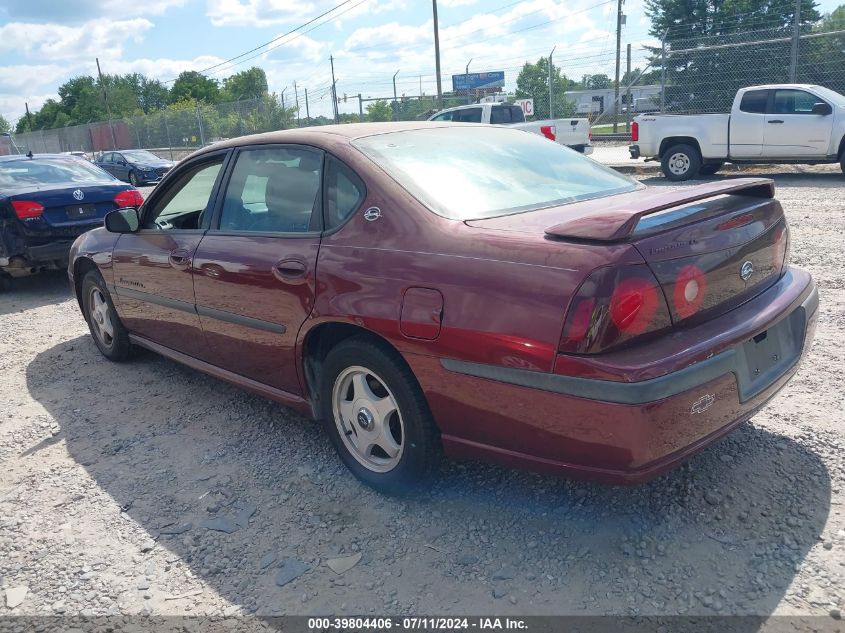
[428,103,593,154]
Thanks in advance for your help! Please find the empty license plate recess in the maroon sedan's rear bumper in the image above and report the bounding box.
[737,307,807,402]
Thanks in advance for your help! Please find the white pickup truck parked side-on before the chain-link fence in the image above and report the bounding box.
[629,84,845,180]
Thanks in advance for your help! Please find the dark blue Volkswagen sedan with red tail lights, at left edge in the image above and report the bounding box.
[0,154,143,282]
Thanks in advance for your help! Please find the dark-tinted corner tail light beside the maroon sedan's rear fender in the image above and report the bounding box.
[559,264,672,354]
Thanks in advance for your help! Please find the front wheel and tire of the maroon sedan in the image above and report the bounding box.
[82,270,132,362]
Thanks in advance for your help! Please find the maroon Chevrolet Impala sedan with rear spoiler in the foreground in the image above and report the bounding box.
[69,123,818,491]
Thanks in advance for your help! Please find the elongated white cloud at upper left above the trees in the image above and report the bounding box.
[0,18,153,62]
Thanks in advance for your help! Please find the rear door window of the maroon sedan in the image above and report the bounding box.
[220,146,323,233]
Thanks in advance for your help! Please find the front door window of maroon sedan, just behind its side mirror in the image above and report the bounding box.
[144,156,223,229]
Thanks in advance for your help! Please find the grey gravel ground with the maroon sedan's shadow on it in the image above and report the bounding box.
[0,168,845,625]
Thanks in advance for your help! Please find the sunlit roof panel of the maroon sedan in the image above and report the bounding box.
[191,121,484,156]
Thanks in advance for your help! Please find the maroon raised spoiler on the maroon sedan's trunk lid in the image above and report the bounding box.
[545,178,775,242]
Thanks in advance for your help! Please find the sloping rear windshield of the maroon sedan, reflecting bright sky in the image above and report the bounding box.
[353,126,640,220]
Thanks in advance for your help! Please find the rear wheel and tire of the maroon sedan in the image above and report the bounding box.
[320,336,441,495]
